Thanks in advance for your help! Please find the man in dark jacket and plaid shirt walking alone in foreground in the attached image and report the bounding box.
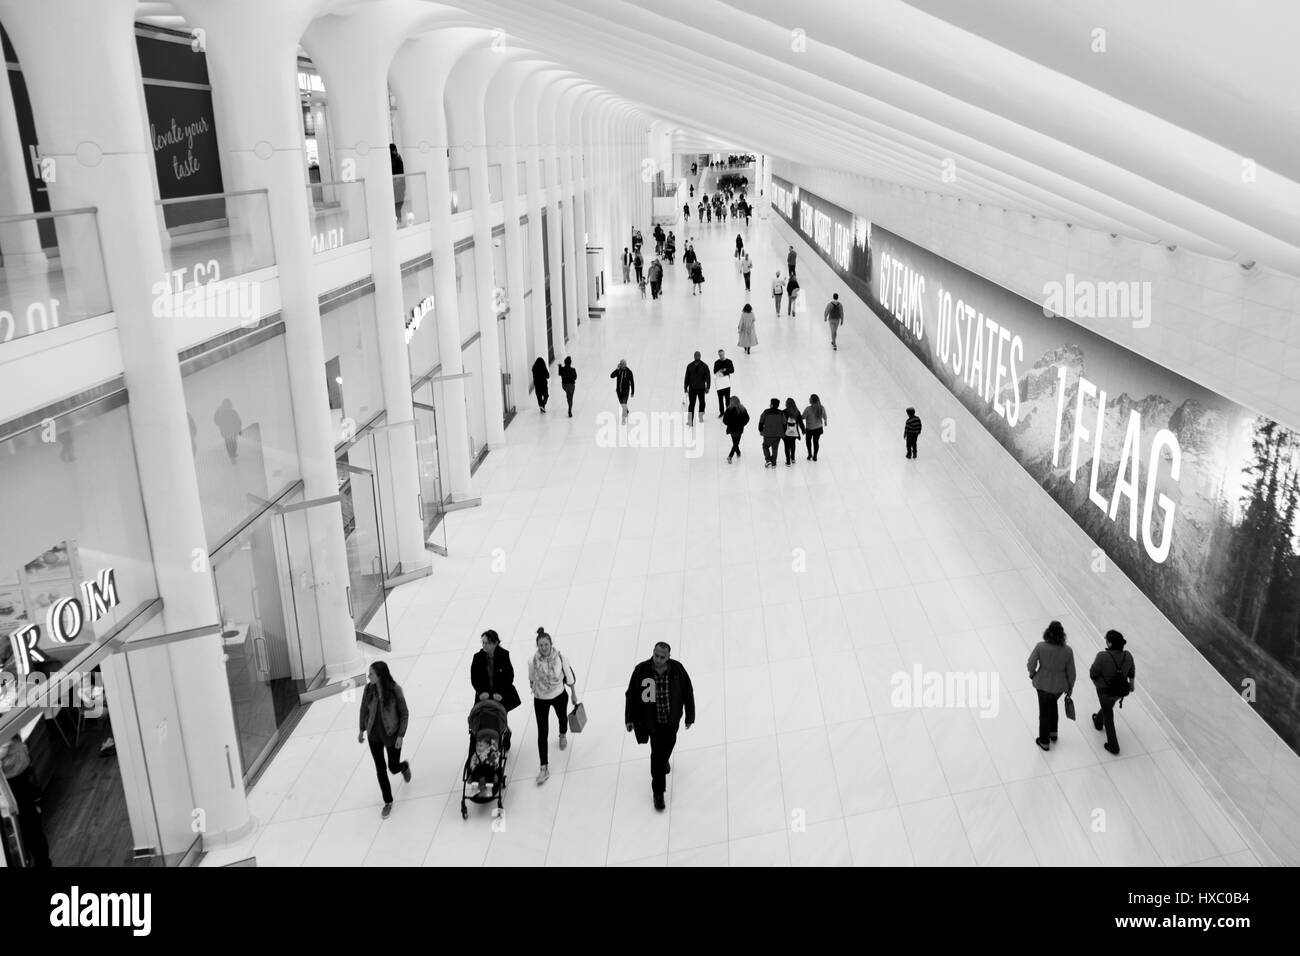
[623,641,696,810]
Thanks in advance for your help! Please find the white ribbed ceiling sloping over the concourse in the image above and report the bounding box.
[134,0,1300,274]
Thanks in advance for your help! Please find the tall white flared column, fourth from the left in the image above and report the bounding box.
[389,34,480,502]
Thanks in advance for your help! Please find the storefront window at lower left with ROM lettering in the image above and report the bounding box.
[0,390,162,866]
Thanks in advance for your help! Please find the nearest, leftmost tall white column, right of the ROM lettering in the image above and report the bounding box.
[0,0,250,852]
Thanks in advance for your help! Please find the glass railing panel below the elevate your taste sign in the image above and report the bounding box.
[156,189,276,293]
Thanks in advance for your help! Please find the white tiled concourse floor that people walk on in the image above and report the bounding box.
[205,213,1257,866]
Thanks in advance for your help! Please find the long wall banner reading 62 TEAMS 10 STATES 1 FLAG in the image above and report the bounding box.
[772,177,1300,752]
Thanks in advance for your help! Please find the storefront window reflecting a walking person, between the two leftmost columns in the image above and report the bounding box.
[182,325,302,548]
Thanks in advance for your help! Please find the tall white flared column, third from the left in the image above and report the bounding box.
[303,12,430,574]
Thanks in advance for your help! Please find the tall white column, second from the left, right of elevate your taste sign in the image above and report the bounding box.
[177,0,365,684]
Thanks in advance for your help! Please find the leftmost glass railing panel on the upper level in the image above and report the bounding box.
[0,208,113,342]
